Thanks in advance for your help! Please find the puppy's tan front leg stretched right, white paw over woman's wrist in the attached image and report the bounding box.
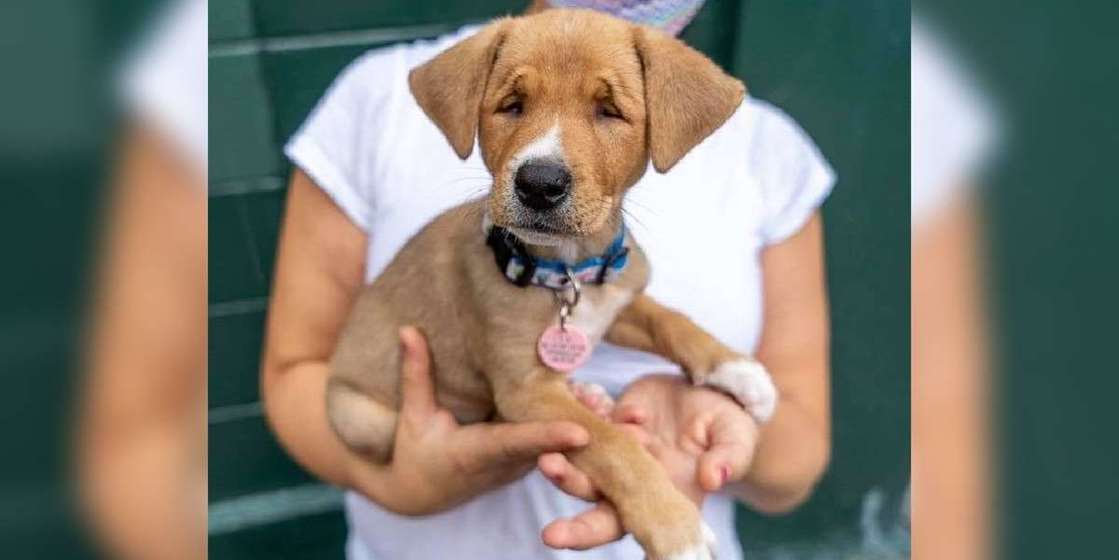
[605,293,778,421]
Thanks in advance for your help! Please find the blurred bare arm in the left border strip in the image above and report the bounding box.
[78,125,206,560]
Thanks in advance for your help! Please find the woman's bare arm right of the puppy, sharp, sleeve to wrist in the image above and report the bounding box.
[728,213,831,513]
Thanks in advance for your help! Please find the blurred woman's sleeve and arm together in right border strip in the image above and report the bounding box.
[910,16,998,560]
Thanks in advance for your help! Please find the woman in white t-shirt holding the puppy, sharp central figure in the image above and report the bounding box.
[262,1,834,560]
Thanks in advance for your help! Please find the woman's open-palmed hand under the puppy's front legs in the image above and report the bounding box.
[538,375,758,550]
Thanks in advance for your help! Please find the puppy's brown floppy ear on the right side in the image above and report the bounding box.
[637,27,746,172]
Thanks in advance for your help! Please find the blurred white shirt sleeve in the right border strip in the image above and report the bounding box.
[910,19,995,225]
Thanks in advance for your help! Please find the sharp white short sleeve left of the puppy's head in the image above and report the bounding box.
[284,48,398,231]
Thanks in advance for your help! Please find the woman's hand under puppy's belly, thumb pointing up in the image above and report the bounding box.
[349,327,590,515]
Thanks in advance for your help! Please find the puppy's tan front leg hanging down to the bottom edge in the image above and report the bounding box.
[495,371,714,560]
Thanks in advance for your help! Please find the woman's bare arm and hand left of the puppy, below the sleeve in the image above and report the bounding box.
[261,170,587,514]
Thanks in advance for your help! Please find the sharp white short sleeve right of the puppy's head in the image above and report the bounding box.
[749,102,836,245]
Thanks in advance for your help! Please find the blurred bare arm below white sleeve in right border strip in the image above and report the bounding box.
[910,193,993,560]
